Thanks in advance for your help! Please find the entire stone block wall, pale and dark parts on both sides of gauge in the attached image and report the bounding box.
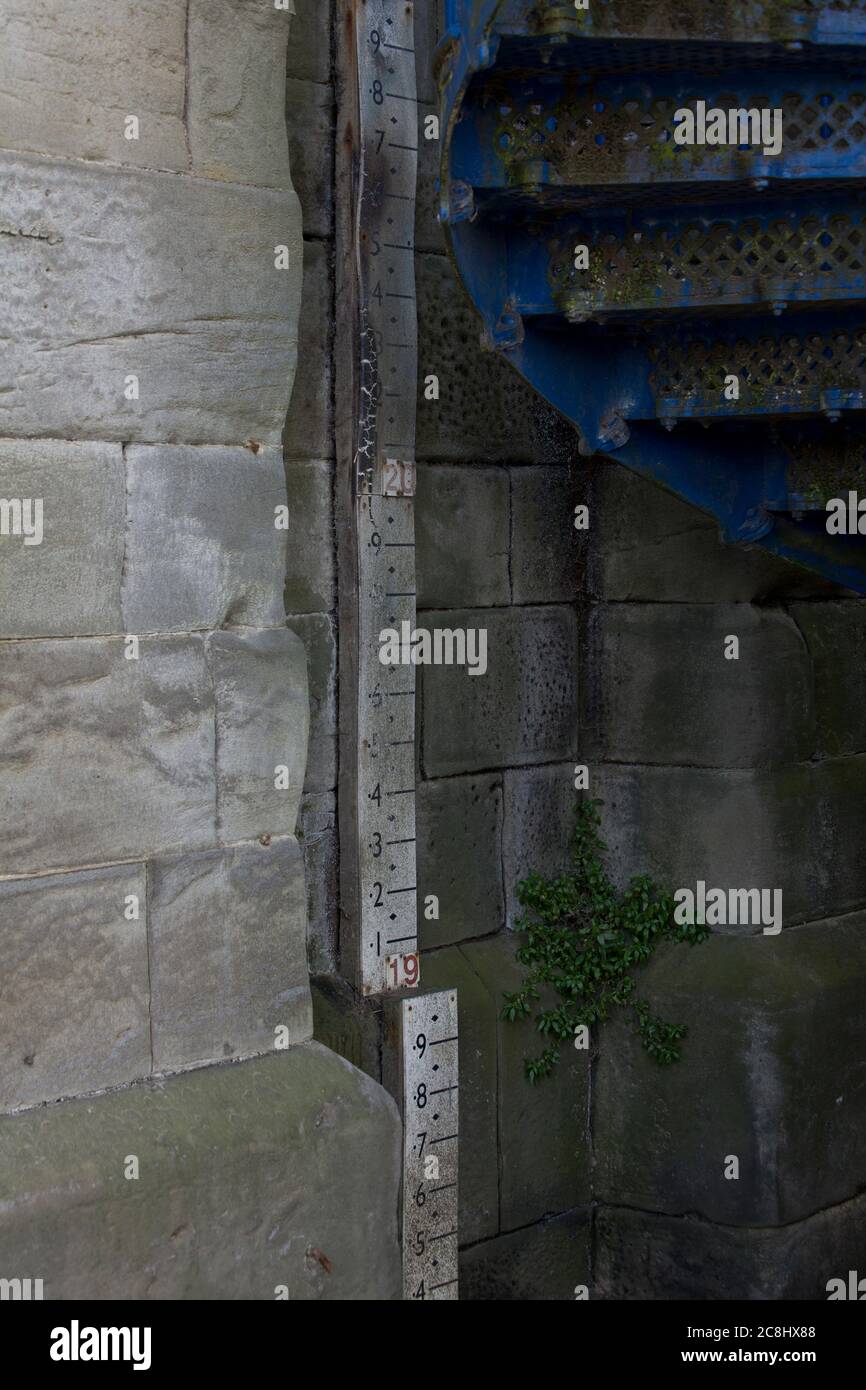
[6,0,866,1300]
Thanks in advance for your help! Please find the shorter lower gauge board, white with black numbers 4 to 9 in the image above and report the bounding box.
[400,990,460,1300]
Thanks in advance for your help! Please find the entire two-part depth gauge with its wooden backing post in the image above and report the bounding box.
[336,0,460,1300]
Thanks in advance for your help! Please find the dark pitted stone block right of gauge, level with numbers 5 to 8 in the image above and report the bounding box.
[421,606,577,777]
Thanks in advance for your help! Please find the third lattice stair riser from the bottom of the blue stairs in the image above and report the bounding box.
[549,213,866,321]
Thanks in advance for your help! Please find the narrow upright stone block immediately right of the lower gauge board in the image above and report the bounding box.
[421,947,499,1244]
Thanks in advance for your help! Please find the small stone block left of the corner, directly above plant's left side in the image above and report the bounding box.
[502,763,578,927]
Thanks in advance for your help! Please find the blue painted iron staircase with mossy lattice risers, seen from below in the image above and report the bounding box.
[438,0,866,592]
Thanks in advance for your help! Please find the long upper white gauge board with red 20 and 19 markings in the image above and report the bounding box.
[354,0,418,994]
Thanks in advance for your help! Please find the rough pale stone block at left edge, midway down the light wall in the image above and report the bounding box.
[0,637,215,874]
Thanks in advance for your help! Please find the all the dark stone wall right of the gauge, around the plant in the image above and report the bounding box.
[354,7,866,1300]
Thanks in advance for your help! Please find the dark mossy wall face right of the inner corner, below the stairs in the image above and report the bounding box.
[592,464,866,1300]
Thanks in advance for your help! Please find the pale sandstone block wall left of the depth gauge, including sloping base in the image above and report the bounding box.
[0,0,399,1298]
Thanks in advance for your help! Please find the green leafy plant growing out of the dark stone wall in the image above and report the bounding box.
[502,801,709,1084]
